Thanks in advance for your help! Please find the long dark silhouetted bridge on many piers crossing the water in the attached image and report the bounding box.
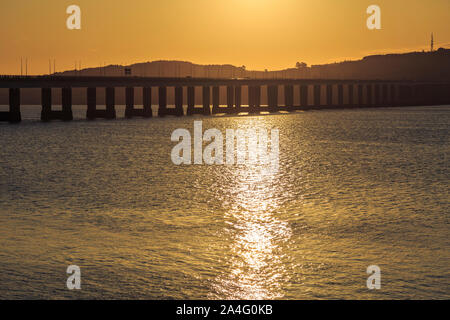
[0,76,450,123]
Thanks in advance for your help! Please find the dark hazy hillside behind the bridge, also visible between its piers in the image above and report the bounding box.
[0,48,450,105]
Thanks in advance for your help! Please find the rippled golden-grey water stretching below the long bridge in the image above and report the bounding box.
[0,106,450,299]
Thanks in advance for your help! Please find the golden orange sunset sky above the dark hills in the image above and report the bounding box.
[0,0,450,74]
